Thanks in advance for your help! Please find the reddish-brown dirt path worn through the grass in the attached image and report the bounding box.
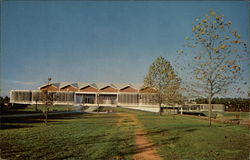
[117,113,162,160]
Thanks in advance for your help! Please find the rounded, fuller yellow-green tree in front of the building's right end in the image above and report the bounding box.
[144,57,180,115]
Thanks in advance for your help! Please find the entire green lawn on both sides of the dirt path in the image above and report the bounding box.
[0,108,249,160]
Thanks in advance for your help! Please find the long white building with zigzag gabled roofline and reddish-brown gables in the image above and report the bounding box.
[10,82,158,107]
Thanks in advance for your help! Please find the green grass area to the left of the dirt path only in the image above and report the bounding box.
[0,114,134,160]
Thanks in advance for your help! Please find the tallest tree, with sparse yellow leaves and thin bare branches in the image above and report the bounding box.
[186,11,247,126]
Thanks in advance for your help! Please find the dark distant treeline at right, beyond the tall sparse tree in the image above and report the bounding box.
[195,97,250,112]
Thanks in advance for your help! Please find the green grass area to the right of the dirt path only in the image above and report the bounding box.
[119,109,249,160]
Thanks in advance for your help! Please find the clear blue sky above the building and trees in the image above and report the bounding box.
[1,1,249,95]
